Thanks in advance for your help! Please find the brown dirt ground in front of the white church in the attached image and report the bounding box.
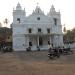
[0,51,75,75]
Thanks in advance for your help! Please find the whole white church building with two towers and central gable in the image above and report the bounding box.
[12,3,63,51]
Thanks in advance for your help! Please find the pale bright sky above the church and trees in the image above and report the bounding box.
[0,0,75,29]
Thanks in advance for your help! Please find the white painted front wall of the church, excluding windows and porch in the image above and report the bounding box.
[12,4,63,51]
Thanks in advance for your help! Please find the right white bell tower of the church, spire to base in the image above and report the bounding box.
[48,5,63,47]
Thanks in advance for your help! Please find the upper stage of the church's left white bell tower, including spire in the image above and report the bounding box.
[13,3,26,24]
